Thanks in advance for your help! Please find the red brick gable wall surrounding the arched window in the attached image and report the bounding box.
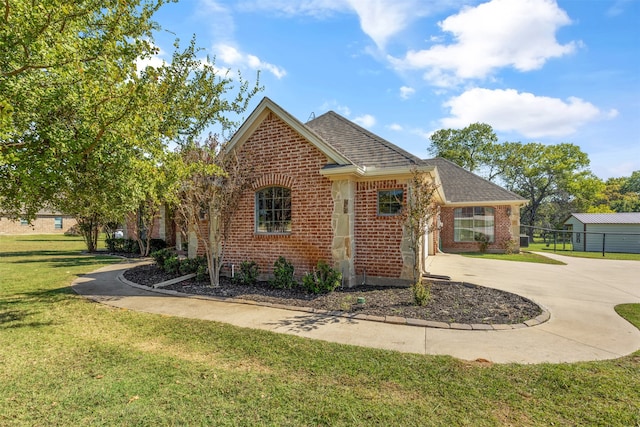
[224,114,333,276]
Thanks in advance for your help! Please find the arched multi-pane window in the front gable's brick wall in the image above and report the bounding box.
[256,187,291,234]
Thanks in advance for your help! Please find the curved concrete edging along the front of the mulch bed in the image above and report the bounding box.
[118,270,551,331]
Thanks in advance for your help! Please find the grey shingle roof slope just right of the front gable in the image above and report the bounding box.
[305,111,422,168]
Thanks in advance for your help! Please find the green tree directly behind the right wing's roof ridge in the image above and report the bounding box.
[428,123,500,180]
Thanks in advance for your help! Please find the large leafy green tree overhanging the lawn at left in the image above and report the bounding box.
[0,0,258,249]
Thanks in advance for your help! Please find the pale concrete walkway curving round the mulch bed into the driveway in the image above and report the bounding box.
[72,254,640,363]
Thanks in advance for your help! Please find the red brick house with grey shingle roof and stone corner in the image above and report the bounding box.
[160,98,526,285]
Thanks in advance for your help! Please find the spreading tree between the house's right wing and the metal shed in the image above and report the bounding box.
[501,142,599,234]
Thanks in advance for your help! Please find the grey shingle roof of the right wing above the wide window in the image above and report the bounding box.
[423,157,526,203]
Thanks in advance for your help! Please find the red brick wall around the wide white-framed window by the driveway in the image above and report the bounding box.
[440,206,517,252]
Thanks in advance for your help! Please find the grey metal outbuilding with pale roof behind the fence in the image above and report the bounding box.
[564,212,640,253]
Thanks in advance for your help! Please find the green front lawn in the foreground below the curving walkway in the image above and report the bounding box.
[0,236,640,426]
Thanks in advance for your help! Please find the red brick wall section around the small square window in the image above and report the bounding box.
[354,180,407,277]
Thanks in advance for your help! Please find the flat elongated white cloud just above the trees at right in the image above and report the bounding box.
[441,88,617,138]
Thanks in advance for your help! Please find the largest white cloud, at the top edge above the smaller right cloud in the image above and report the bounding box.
[389,0,578,86]
